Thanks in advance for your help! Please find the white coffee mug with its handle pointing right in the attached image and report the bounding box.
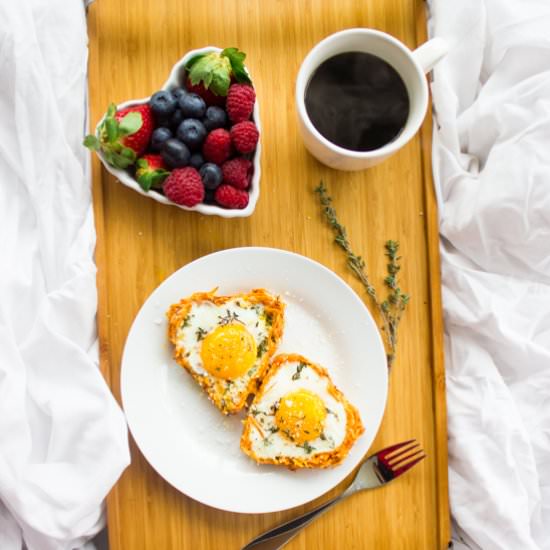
[296,29,448,170]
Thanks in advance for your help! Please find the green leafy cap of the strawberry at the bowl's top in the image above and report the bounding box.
[185,48,252,100]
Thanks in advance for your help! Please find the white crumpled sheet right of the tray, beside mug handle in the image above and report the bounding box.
[430,0,550,550]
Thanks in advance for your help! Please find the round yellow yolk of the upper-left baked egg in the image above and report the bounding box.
[201,323,257,380]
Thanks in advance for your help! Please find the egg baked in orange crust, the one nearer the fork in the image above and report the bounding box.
[241,354,363,467]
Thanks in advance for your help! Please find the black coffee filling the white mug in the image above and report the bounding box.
[305,52,409,151]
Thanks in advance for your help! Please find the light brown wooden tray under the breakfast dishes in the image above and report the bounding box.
[88,0,450,550]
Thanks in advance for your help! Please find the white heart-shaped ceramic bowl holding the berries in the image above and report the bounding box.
[96,46,262,218]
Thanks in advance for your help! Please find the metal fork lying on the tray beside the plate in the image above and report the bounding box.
[241,439,426,550]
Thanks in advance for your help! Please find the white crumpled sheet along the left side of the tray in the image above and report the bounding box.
[0,0,129,550]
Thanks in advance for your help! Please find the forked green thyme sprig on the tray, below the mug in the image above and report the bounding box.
[315,181,410,368]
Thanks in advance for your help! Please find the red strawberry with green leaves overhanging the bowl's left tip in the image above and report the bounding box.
[84,103,154,168]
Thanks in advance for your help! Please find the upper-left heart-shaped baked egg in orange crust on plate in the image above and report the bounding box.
[166,288,285,414]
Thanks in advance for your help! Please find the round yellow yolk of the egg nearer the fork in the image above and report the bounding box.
[275,389,327,445]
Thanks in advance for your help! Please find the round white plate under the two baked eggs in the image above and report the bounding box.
[121,248,387,513]
